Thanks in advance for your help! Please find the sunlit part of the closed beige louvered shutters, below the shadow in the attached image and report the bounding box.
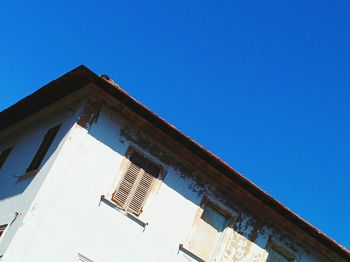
[112,156,155,215]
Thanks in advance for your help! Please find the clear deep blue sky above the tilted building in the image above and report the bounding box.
[0,0,350,248]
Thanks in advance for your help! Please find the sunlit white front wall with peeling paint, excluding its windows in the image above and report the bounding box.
[0,99,332,262]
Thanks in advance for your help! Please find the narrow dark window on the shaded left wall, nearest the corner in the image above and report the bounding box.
[26,125,61,173]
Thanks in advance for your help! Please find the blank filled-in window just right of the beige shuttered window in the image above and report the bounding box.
[188,205,228,261]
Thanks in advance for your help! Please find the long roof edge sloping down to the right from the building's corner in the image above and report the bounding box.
[91,71,350,260]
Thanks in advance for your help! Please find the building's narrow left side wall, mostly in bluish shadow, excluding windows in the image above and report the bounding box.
[0,101,79,261]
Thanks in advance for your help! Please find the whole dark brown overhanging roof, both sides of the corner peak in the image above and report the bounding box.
[0,65,350,261]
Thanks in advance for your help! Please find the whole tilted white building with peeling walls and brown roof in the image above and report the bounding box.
[0,66,350,262]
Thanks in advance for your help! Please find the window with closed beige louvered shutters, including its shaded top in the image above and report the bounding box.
[112,153,161,216]
